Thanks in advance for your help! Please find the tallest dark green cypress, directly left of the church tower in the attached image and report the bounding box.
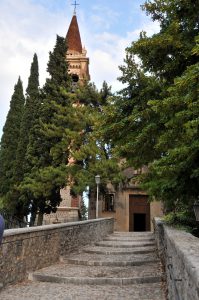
[20,36,70,224]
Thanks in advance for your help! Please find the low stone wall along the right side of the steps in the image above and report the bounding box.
[154,219,199,300]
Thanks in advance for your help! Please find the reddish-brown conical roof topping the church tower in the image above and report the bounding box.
[66,15,82,53]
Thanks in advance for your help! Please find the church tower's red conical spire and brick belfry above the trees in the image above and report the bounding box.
[66,11,90,85]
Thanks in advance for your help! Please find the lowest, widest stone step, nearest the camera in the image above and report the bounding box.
[29,263,163,286]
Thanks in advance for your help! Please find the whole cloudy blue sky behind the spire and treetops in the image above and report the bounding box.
[0,0,159,137]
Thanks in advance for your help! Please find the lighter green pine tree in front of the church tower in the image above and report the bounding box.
[64,82,121,205]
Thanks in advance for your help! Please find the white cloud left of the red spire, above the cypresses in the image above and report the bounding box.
[0,0,67,135]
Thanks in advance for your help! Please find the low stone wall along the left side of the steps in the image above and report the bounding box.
[0,218,114,286]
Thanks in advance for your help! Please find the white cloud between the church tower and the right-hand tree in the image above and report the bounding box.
[87,22,159,91]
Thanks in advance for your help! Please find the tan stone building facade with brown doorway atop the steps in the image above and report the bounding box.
[89,168,163,232]
